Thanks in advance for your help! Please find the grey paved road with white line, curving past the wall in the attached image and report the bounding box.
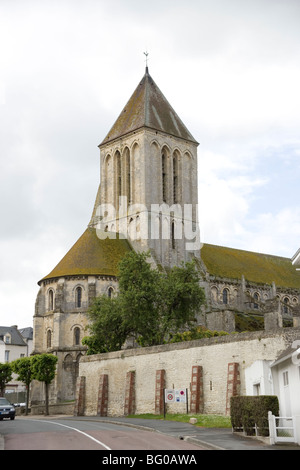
[0,417,205,451]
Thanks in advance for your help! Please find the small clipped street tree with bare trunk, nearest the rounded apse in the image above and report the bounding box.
[31,354,58,415]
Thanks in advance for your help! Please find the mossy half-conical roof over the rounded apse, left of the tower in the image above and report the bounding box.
[38,227,131,284]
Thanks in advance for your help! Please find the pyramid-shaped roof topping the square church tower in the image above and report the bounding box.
[99,67,198,147]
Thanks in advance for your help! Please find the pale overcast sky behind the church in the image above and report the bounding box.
[0,0,300,327]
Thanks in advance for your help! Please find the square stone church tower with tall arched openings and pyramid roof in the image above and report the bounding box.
[90,67,200,267]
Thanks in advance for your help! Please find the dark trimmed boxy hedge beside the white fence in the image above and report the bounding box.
[230,395,279,436]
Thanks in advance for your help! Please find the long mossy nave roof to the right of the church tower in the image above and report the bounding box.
[201,244,300,289]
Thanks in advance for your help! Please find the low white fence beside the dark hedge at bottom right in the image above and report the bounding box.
[268,411,300,445]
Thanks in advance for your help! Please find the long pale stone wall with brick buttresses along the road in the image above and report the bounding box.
[75,328,300,416]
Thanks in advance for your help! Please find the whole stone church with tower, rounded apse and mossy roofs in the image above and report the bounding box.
[31,67,300,404]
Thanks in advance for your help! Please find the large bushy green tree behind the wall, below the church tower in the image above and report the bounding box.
[83,251,204,354]
